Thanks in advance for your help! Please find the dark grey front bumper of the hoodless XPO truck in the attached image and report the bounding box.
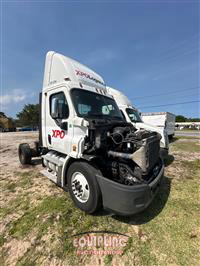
[96,166,164,216]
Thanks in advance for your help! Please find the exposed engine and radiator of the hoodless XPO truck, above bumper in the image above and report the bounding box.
[84,120,161,185]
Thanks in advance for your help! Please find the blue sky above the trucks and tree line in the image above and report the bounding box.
[0,0,200,118]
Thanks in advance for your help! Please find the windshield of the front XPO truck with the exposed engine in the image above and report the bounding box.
[71,89,124,120]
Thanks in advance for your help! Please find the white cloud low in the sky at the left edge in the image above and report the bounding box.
[0,89,27,106]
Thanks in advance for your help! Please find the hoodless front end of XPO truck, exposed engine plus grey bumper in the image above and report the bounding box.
[83,119,164,215]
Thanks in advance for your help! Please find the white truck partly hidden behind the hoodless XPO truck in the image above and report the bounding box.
[106,86,169,159]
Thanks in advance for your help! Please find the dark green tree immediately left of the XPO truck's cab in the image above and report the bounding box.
[16,104,39,128]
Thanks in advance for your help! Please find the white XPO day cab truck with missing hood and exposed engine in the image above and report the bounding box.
[18,51,164,215]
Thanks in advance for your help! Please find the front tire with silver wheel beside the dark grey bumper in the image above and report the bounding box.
[67,161,102,213]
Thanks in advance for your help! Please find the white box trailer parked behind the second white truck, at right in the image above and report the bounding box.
[142,112,176,139]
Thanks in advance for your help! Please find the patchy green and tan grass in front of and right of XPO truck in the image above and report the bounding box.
[0,139,200,266]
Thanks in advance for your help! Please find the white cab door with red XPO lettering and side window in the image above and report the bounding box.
[45,88,73,154]
